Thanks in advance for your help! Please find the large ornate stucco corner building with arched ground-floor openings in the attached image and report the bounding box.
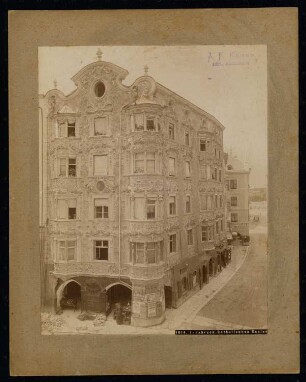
[40,50,227,326]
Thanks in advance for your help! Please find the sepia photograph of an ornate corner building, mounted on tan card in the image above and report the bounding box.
[37,45,269,335]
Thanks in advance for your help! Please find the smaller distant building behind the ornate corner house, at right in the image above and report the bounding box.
[225,156,250,235]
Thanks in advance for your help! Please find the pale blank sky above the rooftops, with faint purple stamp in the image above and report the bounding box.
[39,45,267,187]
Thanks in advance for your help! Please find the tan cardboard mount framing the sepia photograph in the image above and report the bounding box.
[9,8,299,375]
